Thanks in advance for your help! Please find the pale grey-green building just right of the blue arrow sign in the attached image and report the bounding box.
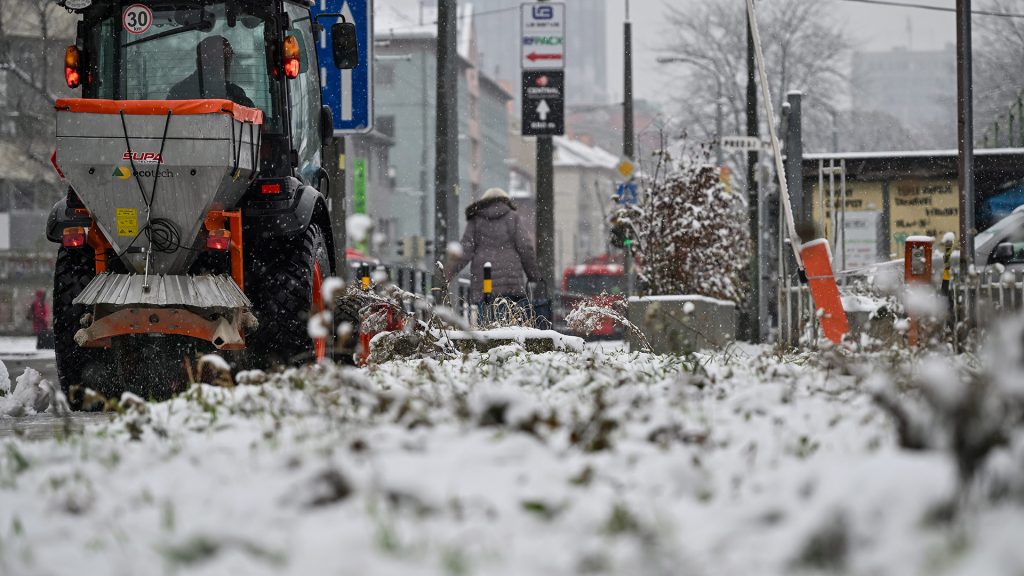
[366,3,512,263]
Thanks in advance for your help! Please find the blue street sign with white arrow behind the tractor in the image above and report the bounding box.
[312,0,374,134]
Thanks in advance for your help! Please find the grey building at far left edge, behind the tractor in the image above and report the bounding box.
[0,0,76,334]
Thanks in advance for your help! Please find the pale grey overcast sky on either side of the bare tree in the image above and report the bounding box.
[602,0,954,101]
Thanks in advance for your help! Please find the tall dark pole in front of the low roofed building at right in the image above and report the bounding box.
[956,0,975,282]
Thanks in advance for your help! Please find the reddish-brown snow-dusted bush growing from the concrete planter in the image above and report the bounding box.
[613,142,751,302]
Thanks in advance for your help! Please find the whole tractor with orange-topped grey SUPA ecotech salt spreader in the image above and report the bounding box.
[47,0,358,403]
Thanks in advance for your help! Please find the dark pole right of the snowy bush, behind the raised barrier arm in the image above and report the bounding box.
[746,7,761,342]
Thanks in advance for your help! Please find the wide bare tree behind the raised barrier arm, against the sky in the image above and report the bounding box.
[662,0,852,156]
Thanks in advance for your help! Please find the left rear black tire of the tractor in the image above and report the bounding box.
[53,247,111,410]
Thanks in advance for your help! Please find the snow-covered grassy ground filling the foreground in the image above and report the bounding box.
[0,345,1024,576]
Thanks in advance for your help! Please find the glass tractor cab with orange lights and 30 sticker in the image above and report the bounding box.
[65,0,357,182]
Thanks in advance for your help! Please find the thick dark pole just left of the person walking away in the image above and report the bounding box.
[433,0,459,293]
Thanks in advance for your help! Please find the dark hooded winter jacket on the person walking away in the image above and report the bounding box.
[450,195,541,302]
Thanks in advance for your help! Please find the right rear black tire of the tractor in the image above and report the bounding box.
[246,224,334,369]
